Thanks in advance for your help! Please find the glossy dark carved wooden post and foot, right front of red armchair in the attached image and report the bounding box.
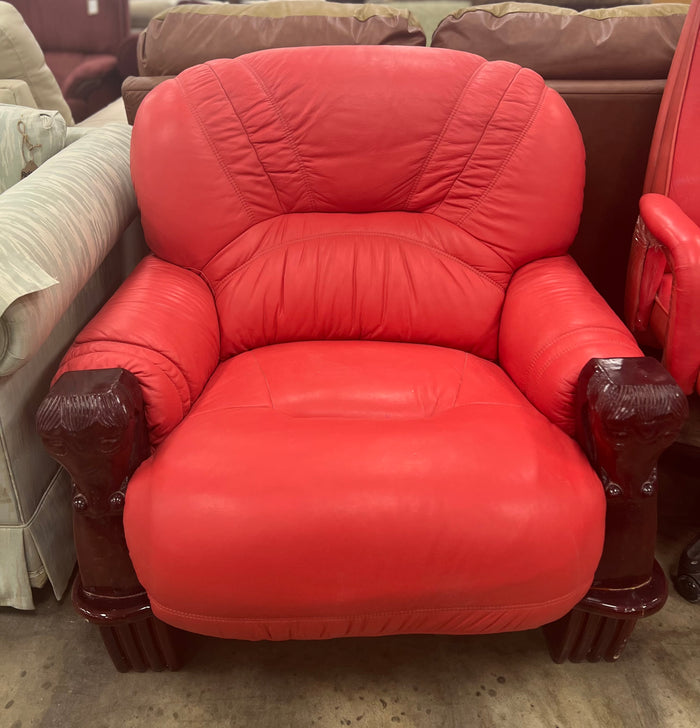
[545,357,688,662]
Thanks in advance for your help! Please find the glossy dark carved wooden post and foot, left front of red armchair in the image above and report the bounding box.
[37,369,178,672]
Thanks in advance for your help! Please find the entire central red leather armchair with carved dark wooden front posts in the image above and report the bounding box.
[38,46,687,670]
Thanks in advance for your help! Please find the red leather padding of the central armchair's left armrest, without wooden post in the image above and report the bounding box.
[54,256,219,445]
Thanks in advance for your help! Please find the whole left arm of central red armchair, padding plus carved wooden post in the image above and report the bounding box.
[37,256,213,671]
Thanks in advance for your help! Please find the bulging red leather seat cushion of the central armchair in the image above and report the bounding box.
[125,341,605,639]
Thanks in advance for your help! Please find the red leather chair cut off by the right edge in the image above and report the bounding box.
[625,0,700,601]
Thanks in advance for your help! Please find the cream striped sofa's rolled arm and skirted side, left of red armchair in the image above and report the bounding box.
[0,124,143,609]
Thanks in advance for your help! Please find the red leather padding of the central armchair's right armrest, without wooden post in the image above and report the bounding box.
[499,256,643,435]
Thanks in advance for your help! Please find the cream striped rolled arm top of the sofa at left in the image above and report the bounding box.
[0,124,137,375]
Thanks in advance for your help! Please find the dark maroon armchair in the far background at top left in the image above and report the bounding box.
[10,0,129,121]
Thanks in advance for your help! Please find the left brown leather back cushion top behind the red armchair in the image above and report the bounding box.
[138,0,426,76]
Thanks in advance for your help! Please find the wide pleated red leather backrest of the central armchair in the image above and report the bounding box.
[132,46,584,358]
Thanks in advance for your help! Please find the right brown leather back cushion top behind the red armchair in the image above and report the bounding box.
[431,2,688,80]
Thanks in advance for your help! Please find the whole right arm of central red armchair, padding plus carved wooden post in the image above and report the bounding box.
[500,256,687,662]
